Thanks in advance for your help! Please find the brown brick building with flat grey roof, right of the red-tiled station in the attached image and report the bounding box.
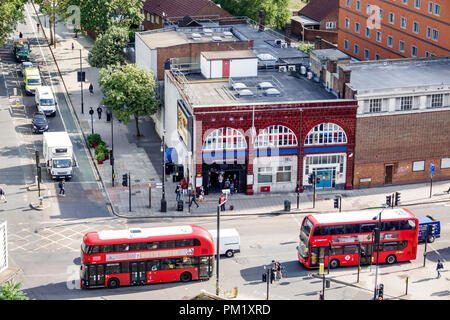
[327,56,450,188]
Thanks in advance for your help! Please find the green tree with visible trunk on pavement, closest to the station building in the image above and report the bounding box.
[99,64,159,137]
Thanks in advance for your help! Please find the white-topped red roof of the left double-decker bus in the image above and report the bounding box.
[83,225,213,245]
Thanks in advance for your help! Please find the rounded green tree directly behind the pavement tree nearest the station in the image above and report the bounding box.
[88,25,129,68]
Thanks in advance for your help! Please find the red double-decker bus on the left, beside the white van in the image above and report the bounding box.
[80,225,214,288]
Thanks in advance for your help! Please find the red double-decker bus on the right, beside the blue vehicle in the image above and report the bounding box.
[297,209,419,268]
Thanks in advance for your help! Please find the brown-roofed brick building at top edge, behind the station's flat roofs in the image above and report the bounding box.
[141,0,232,31]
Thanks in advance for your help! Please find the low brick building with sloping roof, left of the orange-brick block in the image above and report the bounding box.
[291,0,339,44]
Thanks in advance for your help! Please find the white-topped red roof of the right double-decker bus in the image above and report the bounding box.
[306,208,416,225]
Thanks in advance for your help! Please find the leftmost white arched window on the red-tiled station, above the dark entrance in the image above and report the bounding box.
[203,128,247,150]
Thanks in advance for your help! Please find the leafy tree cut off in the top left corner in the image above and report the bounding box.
[0,0,27,48]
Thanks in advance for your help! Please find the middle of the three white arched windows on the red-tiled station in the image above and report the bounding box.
[255,125,297,148]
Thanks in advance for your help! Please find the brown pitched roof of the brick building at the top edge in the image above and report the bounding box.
[143,0,231,17]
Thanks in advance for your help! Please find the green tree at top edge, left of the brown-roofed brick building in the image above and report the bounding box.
[68,0,145,35]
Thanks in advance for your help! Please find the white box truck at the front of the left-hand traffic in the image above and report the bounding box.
[43,131,73,179]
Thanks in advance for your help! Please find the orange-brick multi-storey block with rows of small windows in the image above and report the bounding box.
[338,0,450,60]
